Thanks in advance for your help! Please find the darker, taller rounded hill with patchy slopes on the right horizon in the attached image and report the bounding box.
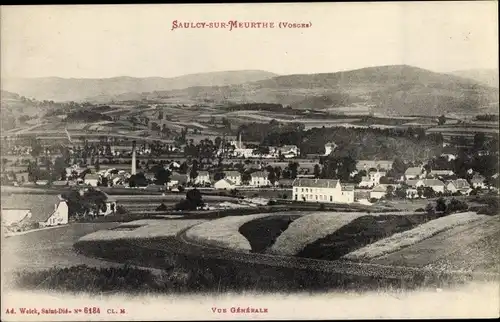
[130,65,498,115]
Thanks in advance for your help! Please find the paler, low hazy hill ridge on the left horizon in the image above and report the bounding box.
[2,70,276,101]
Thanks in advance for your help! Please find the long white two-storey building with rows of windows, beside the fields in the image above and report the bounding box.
[292,178,354,203]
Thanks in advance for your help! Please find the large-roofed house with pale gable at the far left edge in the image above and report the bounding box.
[2,194,68,230]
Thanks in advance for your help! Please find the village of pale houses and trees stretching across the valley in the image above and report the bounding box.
[2,127,498,232]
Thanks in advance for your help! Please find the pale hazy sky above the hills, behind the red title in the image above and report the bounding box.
[0,1,498,78]
